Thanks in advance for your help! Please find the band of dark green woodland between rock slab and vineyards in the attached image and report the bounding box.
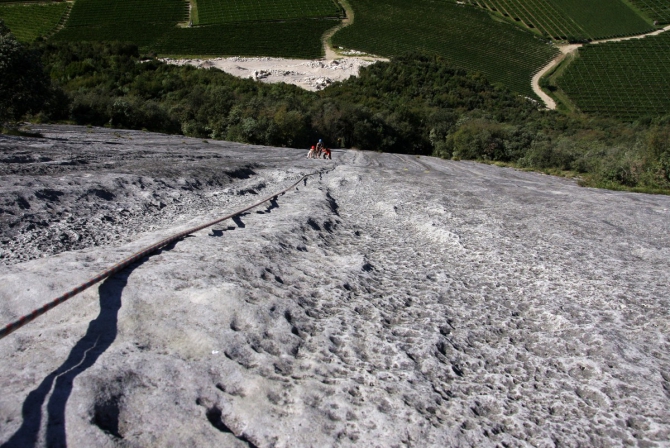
[0,22,670,194]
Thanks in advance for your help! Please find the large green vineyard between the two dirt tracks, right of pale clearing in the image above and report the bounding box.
[333,0,557,98]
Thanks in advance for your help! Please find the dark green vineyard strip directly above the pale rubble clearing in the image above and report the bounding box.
[156,19,339,59]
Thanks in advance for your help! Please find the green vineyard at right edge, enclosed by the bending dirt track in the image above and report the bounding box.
[556,33,670,120]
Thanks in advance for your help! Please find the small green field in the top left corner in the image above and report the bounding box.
[0,3,68,42]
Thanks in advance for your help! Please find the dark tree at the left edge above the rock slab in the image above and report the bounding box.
[0,20,51,125]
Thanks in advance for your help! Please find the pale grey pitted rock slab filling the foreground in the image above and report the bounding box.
[0,126,670,447]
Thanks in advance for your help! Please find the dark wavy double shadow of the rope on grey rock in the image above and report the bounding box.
[0,242,176,448]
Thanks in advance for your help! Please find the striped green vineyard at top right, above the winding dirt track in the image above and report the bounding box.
[469,0,656,40]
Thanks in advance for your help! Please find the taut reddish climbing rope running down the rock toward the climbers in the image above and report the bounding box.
[0,171,323,339]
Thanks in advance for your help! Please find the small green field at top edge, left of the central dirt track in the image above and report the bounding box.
[197,0,342,25]
